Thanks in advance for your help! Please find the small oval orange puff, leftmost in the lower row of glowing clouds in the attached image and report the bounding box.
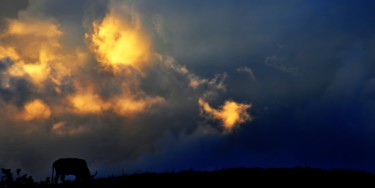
[21,99,52,121]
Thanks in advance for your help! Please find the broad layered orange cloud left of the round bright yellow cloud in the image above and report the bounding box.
[0,12,87,90]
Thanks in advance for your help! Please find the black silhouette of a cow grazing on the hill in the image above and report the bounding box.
[51,158,97,184]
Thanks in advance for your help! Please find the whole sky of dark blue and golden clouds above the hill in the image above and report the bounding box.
[0,0,375,179]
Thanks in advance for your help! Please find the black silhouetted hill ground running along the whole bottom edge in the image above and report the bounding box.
[0,168,375,188]
